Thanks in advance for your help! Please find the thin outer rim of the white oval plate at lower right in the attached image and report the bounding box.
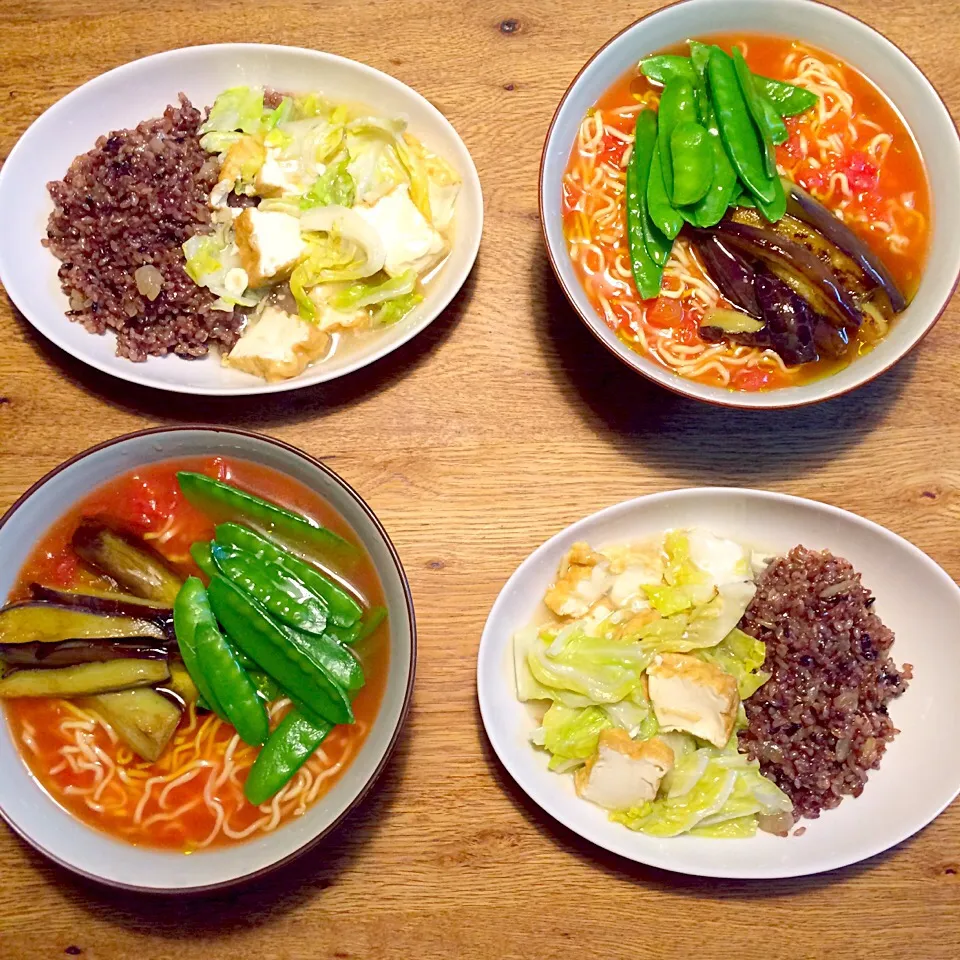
[475,484,960,882]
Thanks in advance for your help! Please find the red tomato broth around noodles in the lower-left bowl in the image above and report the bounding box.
[5,458,389,853]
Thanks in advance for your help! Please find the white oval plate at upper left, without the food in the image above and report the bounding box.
[0,43,483,396]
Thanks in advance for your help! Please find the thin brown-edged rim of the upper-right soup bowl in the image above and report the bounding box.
[538,0,960,410]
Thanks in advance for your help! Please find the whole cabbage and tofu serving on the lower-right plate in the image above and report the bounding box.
[514,530,791,837]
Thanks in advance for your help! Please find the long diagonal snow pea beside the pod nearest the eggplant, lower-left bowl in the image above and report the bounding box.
[208,575,353,723]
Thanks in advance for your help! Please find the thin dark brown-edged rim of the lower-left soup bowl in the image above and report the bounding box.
[0,424,417,897]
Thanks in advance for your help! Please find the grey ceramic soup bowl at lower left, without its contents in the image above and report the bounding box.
[0,427,416,893]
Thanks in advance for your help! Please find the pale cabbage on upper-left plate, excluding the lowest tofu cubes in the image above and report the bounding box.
[184,87,460,344]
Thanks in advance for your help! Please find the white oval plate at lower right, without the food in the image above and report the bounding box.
[477,488,960,879]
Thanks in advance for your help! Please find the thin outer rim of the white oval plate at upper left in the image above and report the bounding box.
[0,42,484,397]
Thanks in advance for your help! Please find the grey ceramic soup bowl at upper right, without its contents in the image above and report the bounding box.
[540,0,960,408]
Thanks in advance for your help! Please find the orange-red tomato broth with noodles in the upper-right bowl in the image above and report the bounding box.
[562,34,930,392]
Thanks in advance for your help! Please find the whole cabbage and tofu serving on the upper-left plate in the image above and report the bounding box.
[183,87,460,380]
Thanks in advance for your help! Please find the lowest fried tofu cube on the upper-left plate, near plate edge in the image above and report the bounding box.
[223,306,330,381]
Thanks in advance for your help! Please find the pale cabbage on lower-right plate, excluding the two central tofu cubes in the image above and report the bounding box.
[514,530,791,837]
